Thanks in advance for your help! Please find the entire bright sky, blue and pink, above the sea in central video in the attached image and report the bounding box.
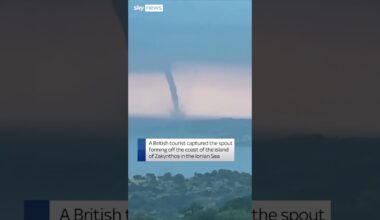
[128,0,252,118]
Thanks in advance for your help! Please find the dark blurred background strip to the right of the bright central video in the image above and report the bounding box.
[253,0,380,220]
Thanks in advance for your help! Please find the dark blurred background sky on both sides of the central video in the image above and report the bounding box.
[0,0,380,137]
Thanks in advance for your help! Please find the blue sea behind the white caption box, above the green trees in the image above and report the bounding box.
[128,118,252,178]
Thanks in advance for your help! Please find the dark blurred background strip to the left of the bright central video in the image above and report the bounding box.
[0,0,128,219]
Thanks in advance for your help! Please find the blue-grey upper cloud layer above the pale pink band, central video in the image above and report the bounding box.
[128,0,252,72]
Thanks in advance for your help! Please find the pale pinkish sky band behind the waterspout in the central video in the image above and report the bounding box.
[129,64,252,118]
